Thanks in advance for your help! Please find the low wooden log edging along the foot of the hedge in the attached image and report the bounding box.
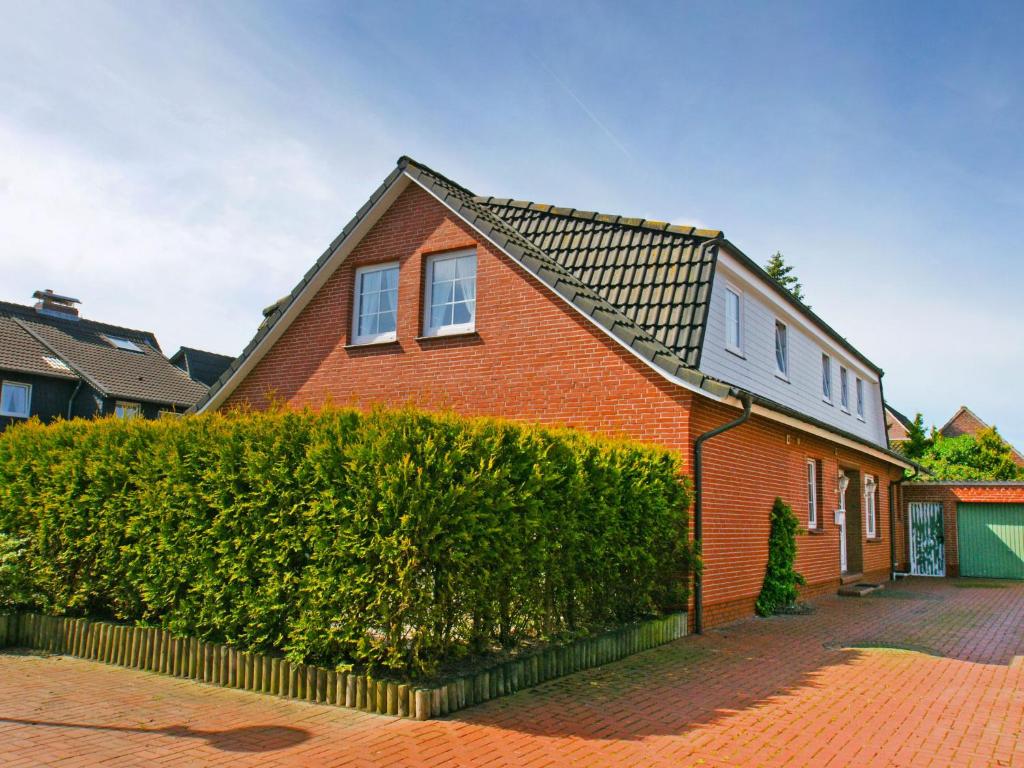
[0,613,687,720]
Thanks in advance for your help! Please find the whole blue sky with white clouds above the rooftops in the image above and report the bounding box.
[0,2,1024,446]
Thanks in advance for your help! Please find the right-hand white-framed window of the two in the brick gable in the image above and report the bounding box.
[423,251,476,336]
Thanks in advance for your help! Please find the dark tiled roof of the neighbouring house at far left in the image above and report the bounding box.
[0,302,206,408]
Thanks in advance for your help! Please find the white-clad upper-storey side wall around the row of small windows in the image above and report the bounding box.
[700,253,886,446]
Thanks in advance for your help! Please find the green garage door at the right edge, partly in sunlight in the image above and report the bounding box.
[956,504,1024,579]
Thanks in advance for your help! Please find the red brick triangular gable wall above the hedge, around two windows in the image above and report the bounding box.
[226,185,691,450]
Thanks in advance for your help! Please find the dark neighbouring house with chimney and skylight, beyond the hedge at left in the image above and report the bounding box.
[0,290,207,430]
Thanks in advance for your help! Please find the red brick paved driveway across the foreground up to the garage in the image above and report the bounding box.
[0,580,1024,768]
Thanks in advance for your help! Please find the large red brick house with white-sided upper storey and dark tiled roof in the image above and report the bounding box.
[192,158,909,625]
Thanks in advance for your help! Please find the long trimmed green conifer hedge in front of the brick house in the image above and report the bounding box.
[0,410,690,675]
